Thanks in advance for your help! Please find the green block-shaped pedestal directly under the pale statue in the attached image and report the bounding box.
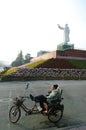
[57,43,74,51]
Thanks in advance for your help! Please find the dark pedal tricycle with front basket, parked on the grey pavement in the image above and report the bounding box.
[9,84,64,123]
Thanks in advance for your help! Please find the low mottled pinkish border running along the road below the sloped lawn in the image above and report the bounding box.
[2,68,86,80]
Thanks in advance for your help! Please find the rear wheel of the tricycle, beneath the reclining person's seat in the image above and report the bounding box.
[48,108,63,123]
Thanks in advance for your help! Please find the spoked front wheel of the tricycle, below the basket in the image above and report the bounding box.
[9,105,21,123]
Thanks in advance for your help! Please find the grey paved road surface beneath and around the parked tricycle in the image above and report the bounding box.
[0,80,86,130]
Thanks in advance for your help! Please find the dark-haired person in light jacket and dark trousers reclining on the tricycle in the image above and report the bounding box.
[30,84,61,113]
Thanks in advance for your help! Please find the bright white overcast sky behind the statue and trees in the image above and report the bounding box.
[0,0,86,63]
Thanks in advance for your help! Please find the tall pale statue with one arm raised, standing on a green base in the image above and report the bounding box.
[57,24,70,43]
